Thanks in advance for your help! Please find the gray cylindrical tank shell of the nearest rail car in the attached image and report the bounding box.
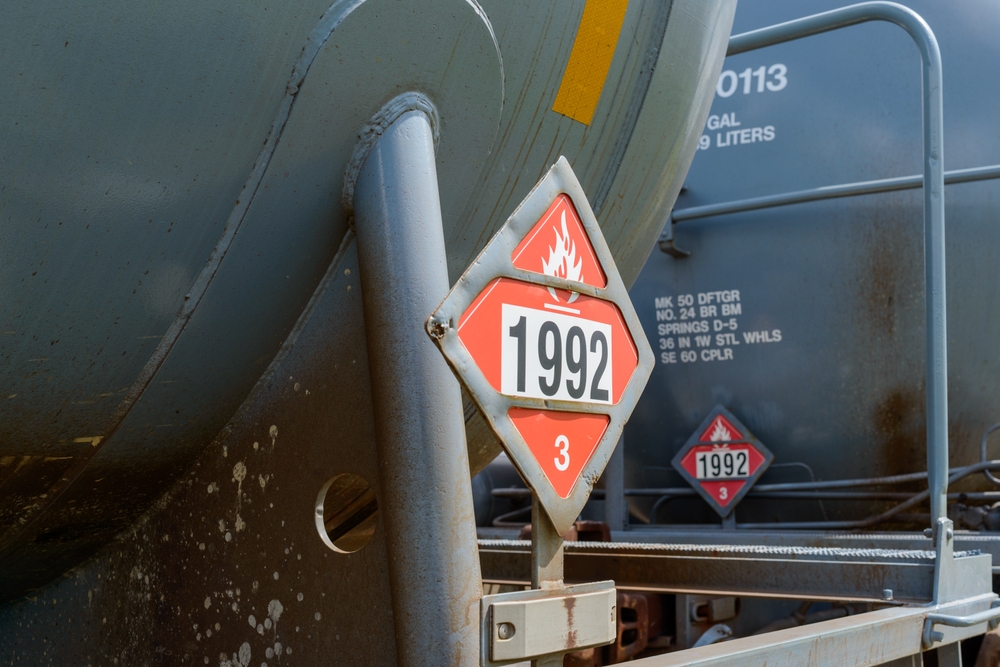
[0,0,735,604]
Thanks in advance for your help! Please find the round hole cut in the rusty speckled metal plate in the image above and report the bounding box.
[316,473,378,554]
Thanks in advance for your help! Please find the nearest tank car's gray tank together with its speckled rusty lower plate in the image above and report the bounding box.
[0,0,735,667]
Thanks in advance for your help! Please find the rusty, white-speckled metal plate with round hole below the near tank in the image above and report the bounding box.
[0,237,397,667]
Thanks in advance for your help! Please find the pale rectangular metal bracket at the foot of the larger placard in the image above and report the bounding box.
[480,581,617,667]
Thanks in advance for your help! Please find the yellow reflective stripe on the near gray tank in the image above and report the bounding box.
[552,0,628,125]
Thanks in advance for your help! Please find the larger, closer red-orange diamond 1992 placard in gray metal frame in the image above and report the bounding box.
[427,158,653,534]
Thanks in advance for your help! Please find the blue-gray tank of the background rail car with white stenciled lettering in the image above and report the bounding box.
[626,2,1000,526]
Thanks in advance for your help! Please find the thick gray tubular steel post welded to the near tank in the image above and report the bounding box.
[354,103,482,667]
